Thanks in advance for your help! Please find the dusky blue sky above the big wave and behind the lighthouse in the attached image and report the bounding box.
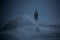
[1,0,60,25]
